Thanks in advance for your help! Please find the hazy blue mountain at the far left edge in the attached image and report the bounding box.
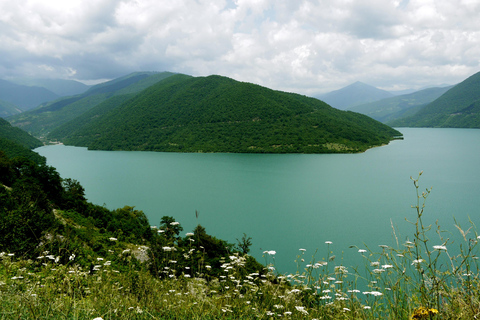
[0,79,58,111]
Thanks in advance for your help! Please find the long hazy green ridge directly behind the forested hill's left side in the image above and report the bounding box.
[9,72,177,137]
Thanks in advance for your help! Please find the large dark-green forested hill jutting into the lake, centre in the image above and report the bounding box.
[59,75,401,153]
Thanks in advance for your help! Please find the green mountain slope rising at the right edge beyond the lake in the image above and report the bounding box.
[389,72,480,128]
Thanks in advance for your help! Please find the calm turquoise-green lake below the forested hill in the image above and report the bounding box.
[35,128,480,273]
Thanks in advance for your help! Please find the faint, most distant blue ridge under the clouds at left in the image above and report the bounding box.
[10,78,90,97]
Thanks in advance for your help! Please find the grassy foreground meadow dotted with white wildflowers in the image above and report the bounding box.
[0,176,480,320]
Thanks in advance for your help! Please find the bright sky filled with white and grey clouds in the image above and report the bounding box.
[0,0,480,95]
